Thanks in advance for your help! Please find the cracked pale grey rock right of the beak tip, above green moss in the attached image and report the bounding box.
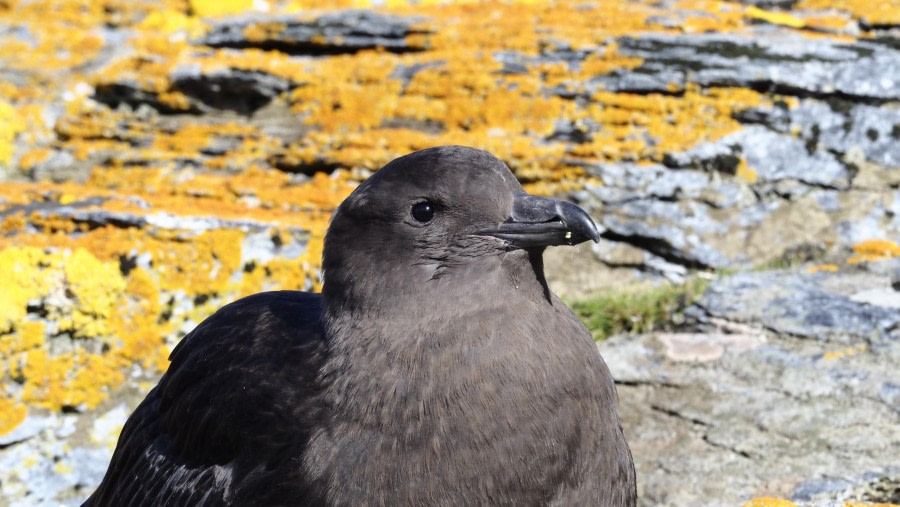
[581,138,900,271]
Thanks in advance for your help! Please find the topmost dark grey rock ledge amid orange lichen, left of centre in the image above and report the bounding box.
[196,10,424,55]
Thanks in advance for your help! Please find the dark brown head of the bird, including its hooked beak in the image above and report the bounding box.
[323,146,600,316]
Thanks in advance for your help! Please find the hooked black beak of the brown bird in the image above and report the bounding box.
[475,192,600,250]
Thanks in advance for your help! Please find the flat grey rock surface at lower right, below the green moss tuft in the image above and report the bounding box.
[600,263,900,506]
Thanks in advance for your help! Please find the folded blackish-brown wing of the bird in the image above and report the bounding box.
[85,291,326,505]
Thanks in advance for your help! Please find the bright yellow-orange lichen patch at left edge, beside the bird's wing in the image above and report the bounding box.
[0,246,151,409]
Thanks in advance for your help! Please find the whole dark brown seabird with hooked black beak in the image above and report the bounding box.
[86,147,635,506]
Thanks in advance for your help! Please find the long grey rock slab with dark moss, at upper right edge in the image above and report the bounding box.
[587,26,900,103]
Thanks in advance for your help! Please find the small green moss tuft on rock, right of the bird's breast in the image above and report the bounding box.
[569,278,709,340]
